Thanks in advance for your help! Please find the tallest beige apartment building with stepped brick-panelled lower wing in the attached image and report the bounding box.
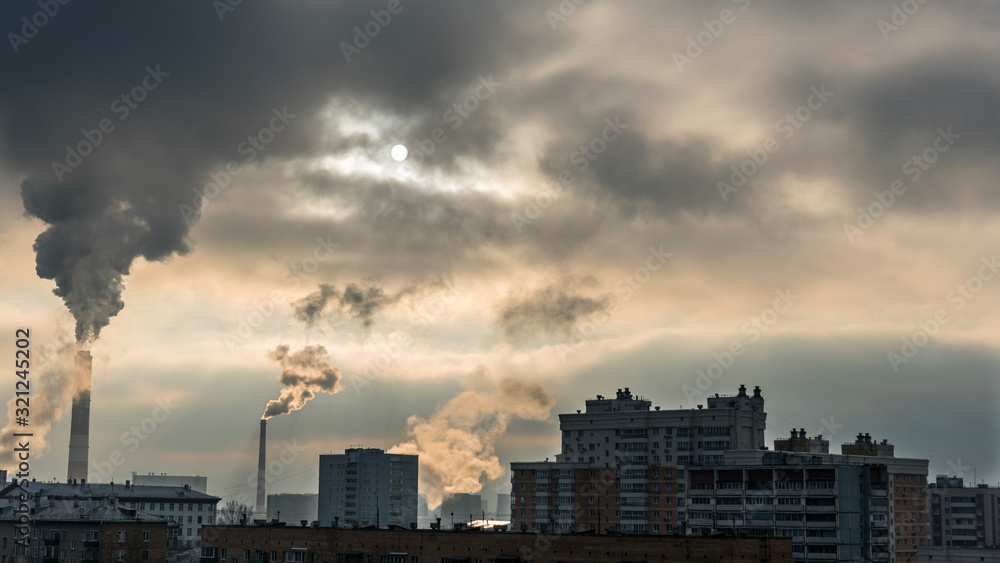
[511,385,767,534]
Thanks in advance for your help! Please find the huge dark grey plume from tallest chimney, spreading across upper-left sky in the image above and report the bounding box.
[0,2,548,340]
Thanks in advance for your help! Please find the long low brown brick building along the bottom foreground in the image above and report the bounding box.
[201,526,792,563]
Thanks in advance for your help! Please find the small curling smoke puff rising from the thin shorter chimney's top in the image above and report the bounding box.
[261,344,343,419]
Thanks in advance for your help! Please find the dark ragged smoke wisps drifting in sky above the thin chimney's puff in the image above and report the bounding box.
[292,278,445,333]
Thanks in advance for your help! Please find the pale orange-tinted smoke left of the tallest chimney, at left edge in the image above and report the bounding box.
[0,344,89,468]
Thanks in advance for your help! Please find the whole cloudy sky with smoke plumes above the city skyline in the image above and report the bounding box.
[0,0,1000,512]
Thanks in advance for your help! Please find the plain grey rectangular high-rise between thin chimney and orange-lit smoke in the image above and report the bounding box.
[318,448,418,528]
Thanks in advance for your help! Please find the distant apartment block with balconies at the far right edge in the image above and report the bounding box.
[928,475,1000,547]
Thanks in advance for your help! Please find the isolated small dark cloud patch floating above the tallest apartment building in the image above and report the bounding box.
[494,277,612,344]
